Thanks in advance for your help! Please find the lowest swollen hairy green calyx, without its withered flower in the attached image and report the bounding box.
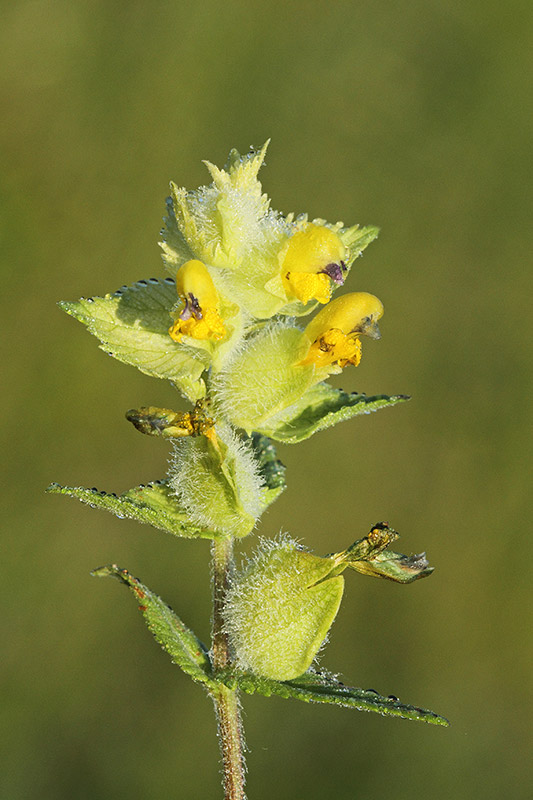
[224,537,344,681]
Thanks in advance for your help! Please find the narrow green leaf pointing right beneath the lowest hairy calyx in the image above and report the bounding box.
[217,671,449,726]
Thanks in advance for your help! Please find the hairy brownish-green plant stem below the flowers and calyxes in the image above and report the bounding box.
[211,537,245,800]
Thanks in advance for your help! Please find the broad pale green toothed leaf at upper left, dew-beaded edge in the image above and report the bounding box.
[59,278,206,400]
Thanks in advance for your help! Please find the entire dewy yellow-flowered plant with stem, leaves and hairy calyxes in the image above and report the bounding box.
[49,143,447,800]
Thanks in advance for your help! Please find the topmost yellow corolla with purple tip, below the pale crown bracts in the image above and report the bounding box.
[281,223,346,304]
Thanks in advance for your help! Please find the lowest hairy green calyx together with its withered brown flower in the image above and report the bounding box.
[225,523,433,681]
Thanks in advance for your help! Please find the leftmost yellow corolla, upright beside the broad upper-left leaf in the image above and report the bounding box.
[168,260,226,342]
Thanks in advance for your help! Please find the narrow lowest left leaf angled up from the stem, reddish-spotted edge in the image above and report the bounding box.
[91,564,216,686]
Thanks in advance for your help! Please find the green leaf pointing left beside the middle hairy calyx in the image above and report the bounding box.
[46,481,217,539]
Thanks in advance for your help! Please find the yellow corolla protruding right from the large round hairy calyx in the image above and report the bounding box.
[301,292,383,367]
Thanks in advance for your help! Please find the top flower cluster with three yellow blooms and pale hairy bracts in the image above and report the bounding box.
[158,139,383,424]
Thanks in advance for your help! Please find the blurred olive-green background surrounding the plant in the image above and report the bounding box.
[0,0,533,800]
